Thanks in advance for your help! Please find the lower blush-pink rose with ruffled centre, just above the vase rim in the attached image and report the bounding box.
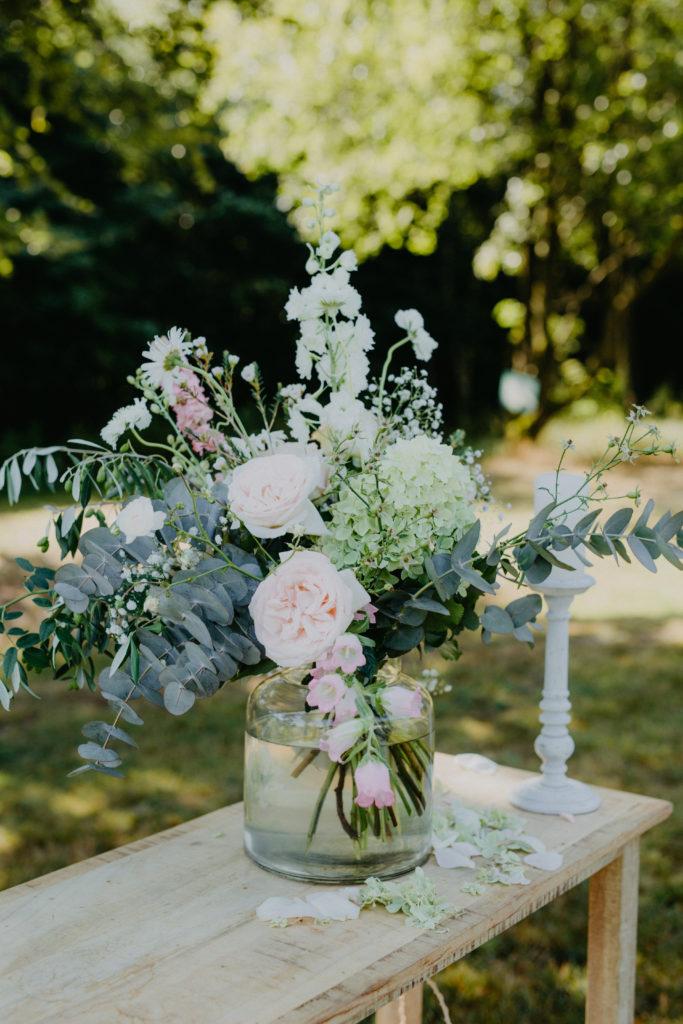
[249,551,369,668]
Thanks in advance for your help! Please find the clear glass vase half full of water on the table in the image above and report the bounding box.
[245,675,433,882]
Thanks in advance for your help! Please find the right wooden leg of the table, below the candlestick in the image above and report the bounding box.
[586,839,639,1024]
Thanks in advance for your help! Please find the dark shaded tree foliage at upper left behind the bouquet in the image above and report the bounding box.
[0,0,295,452]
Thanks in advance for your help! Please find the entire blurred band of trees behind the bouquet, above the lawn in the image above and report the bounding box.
[0,0,683,453]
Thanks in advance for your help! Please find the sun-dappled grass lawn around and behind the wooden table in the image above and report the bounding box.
[0,419,683,1024]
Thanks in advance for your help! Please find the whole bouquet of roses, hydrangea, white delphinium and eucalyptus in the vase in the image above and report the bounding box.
[0,185,683,856]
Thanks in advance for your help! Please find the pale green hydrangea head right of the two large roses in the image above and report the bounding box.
[323,434,475,585]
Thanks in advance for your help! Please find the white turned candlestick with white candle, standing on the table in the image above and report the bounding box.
[508,473,600,814]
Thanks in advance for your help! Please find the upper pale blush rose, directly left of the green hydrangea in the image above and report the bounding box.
[227,452,327,538]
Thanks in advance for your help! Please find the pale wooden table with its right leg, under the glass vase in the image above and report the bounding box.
[0,755,671,1024]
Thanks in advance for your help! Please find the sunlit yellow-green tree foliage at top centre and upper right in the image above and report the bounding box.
[204,0,683,427]
